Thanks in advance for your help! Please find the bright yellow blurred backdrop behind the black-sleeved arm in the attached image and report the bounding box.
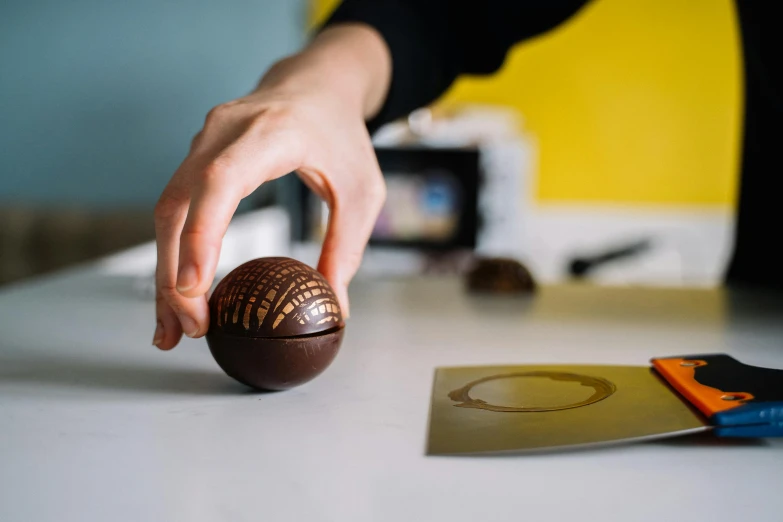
[311,0,742,206]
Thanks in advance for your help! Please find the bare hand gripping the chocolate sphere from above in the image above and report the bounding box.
[153,25,385,350]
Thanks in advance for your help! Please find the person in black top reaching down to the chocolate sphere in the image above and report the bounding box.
[153,0,783,349]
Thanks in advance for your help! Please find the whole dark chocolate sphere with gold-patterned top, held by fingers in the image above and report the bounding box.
[207,257,344,390]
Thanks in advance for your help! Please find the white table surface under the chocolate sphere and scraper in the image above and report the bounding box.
[0,260,783,522]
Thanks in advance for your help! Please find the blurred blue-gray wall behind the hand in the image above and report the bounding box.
[0,0,306,207]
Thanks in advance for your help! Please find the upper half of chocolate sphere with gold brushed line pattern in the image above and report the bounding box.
[209,257,343,338]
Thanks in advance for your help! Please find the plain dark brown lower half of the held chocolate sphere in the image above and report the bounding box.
[207,326,345,390]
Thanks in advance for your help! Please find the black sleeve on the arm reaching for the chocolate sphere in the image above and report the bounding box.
[325,0,588,131]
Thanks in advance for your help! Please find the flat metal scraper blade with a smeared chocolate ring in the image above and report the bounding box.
[427,365,708,455]
